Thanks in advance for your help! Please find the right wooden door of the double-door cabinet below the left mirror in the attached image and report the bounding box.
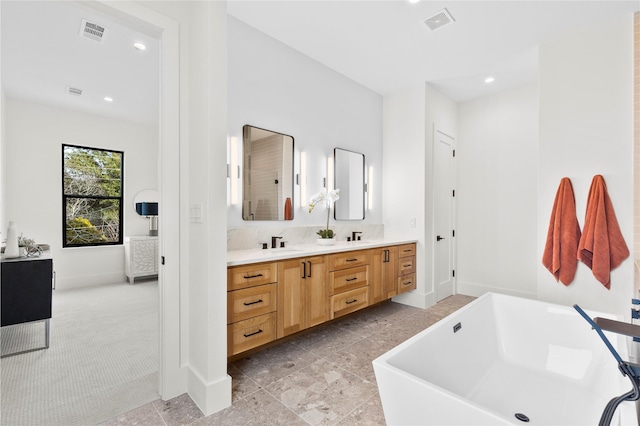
[304,256,330,328]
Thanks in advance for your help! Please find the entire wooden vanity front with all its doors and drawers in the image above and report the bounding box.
[227,243,416,356]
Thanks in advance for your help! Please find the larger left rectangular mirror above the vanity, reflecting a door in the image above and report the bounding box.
[242,125,293,220]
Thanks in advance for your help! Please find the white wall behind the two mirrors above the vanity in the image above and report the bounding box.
[228,17,382,227]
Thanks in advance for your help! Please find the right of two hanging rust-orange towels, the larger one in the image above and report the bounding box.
[578,175,629,288]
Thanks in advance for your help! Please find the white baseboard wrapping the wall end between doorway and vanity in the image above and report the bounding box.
[187,368,231,416]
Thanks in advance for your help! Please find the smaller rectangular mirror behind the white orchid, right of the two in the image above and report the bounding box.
[333,148,365,220]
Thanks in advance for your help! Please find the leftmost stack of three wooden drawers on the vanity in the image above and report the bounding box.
[227,262,278,356]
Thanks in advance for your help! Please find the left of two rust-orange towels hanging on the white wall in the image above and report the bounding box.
[542,177,580,285]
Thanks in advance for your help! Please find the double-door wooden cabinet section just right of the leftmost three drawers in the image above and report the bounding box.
[277,256,329,338]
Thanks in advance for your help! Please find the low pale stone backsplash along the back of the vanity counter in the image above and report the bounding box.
[227,223,384,251]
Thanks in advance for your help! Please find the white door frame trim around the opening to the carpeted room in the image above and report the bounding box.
[91,0,187,400]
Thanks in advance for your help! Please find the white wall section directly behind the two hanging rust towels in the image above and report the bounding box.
[536,15,633,316]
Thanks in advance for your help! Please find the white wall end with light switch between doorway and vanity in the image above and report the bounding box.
[127,1,231,415]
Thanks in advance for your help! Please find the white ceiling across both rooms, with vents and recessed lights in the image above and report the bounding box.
[0,0,640,123]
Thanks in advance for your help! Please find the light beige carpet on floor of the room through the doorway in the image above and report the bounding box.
[0,281,158,426]
